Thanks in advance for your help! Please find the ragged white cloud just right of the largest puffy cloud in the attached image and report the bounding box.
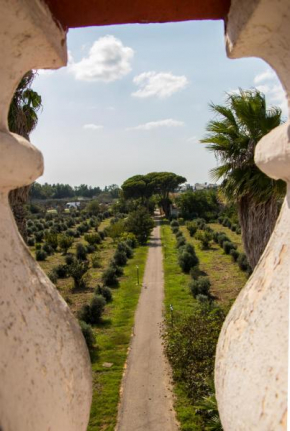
[132,72,188,99]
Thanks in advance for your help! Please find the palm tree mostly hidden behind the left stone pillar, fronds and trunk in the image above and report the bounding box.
[8,71,42,241]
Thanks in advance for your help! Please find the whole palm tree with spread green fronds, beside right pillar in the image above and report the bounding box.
[201,89,285,268]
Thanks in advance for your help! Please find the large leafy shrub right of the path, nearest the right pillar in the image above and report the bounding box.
[165,301,224,404]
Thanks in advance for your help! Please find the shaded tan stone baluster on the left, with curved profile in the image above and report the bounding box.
[0,0,91,431]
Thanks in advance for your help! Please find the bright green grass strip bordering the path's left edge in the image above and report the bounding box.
[88,246,148,431]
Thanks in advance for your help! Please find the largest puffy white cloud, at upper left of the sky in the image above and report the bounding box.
[68,35,134,82]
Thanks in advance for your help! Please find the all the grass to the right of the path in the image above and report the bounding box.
[162,221,247,431]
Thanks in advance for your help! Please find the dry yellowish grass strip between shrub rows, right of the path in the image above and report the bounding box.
[180,225,248,308]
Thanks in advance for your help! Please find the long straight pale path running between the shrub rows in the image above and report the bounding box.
[116,217,178,431]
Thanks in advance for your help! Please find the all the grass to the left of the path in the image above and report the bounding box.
[30,219,148,431]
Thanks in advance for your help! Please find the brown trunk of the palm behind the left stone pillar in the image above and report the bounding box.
[9,186,30,242]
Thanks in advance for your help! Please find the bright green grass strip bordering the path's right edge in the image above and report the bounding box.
[161,222,199,431]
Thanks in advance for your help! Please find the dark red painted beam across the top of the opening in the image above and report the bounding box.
[45,0,230,28]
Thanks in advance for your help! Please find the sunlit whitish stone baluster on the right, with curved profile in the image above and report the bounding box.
[215,0,290,431]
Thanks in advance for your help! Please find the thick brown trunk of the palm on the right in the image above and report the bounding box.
[238,195,278,269]
